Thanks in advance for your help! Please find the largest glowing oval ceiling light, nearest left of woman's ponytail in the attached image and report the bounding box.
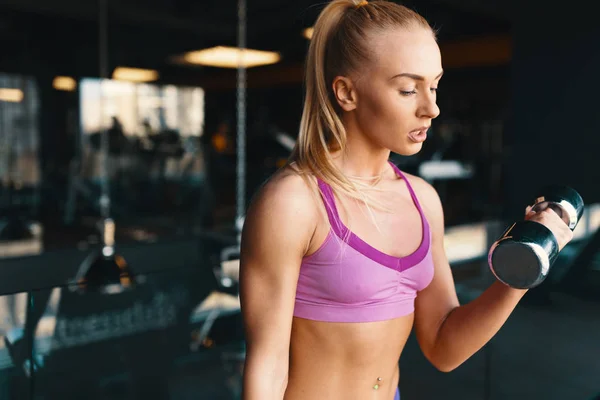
[183,46,281,68]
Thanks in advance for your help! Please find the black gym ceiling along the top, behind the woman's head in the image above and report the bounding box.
[0,0,510,84]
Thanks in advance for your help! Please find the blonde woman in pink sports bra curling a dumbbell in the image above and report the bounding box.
[240,0,572,400]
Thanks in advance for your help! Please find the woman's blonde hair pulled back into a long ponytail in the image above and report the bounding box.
[289,0,433,212]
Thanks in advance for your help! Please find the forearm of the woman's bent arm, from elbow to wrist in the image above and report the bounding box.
[432,282,527,371]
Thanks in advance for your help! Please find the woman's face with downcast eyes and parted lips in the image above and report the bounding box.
[342,28,443,155]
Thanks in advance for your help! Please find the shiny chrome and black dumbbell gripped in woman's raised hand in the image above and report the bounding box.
[488,185,584,289]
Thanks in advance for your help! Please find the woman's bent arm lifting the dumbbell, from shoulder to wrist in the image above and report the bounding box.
[411,178,526,372]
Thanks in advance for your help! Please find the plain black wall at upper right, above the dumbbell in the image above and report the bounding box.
[505,0,600,217]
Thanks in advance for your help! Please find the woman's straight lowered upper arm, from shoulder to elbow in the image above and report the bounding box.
[240,175,314,372]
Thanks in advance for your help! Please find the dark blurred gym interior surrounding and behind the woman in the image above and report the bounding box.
[0,0,600,400]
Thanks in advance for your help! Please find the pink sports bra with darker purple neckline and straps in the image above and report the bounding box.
[294,162,434,322]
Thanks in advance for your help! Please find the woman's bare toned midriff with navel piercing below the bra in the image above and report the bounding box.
[285,314,413,400]
